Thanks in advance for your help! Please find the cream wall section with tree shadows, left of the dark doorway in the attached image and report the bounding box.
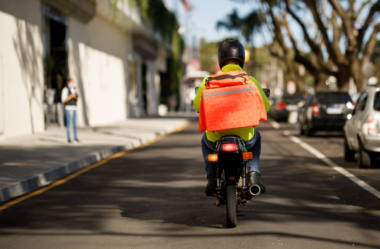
[0,0,44,139]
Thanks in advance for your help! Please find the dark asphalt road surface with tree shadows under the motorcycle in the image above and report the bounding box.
[0,123,380,249]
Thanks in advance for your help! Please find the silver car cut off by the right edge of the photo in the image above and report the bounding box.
[344,85,380,168]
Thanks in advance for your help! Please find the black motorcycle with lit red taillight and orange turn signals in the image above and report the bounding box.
[197,89,270,228]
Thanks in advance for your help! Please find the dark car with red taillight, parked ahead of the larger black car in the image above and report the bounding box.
[268,94,305,121]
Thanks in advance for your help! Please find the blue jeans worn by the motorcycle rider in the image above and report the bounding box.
[202,130,261,174]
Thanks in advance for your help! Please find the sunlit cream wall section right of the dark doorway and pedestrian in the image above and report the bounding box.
[68,16,131,126]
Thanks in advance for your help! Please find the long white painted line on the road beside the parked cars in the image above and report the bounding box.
[284,131,380,199]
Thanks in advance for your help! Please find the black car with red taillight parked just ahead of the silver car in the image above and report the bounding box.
[298,92,354,136]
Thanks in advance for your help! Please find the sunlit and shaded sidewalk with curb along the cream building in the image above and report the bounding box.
[0,117,191,203]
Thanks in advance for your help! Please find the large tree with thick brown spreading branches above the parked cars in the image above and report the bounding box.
[235,0,380,91]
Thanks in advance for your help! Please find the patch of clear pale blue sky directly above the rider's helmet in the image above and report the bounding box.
[188,0,264,46]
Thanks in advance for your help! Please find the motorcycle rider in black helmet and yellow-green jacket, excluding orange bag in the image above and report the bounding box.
[194,39,270,196]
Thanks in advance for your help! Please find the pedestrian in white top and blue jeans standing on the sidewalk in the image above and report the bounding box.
[61,79,79,144]
